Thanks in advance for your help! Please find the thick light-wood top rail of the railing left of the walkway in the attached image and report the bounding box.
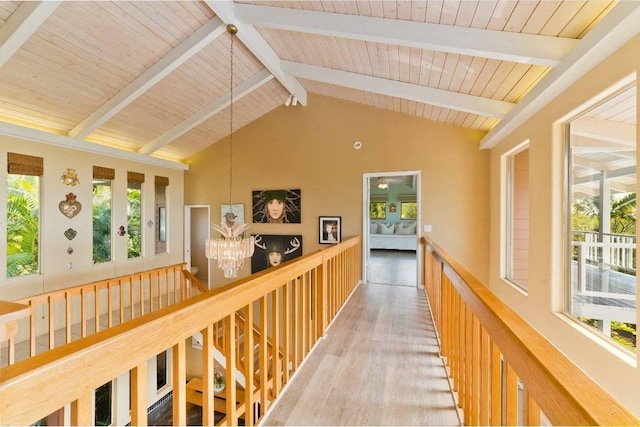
[0,236,360,425]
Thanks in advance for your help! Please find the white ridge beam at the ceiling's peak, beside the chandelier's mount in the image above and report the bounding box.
[205,0,307,105]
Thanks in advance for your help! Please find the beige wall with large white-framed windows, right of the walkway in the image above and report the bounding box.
[490,37,640,415]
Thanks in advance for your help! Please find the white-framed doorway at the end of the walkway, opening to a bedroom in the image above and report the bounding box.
[362,171,422,286]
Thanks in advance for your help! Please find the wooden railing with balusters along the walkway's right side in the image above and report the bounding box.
[421,238,640,426]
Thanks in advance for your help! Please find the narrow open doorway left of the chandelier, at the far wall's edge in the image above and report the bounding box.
[184,205,211,289]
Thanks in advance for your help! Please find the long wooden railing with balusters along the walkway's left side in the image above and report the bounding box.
[0,236,361,425]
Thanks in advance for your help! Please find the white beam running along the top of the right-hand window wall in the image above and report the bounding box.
[480,1,640,148]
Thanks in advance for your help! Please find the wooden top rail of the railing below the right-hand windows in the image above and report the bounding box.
[421,237,640,425]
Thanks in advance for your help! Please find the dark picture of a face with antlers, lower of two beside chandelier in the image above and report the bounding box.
[251,234,302,273]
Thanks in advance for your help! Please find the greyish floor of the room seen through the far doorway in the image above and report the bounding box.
[368,249,418,287]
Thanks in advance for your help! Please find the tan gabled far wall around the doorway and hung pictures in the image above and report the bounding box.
[185,94,489,287]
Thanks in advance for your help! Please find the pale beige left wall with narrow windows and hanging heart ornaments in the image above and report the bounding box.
[0,136,184,300]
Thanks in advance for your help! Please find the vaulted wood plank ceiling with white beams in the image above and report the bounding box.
[0,0,640,167]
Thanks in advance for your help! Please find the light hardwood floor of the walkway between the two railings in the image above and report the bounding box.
[262,283,461,426]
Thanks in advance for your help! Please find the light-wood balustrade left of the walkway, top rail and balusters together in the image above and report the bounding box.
[0,236,361,425]
